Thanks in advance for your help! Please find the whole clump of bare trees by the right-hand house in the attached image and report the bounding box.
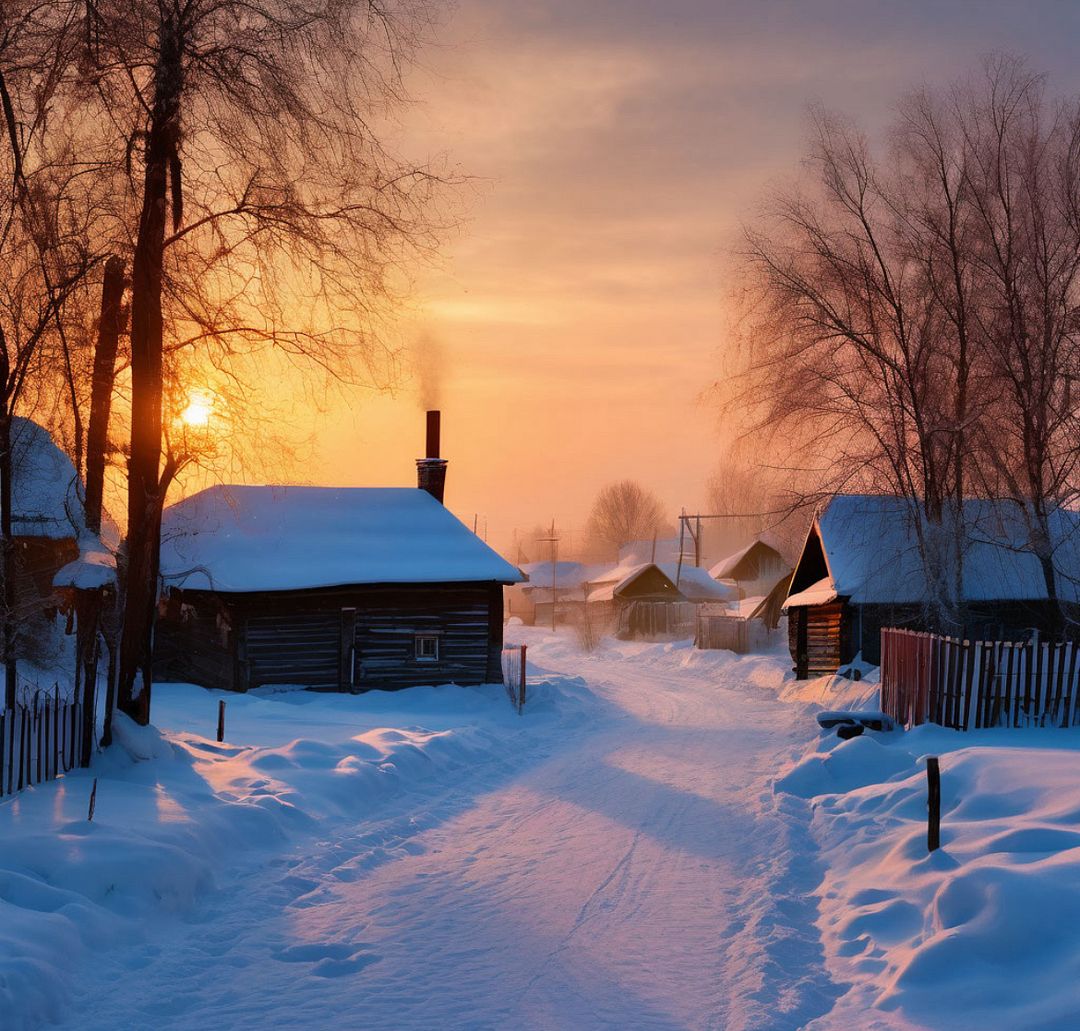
[746,56,1080,639]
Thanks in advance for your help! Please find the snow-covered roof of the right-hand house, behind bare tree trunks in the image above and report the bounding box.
[786,494,1080,607]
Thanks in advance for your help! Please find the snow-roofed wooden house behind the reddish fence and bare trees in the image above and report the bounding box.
[784,494,1080,674]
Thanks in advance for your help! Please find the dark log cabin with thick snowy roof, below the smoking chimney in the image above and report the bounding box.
[154,486,524,691]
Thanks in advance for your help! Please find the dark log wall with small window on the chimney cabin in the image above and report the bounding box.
[154,583,502,691]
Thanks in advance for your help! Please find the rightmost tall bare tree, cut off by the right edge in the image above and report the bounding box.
[953,57,1080,619]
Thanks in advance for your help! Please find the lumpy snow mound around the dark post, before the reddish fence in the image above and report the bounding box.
[777,725,1080,1029]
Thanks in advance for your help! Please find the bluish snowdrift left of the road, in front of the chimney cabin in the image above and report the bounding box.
[0,670,595,1031]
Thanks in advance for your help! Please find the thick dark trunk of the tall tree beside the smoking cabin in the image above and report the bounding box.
[117,18,184,724]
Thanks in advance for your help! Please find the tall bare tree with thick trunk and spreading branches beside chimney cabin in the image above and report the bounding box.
[52,0,449,721]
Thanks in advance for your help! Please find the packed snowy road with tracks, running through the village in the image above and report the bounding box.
[54,648,840,1031]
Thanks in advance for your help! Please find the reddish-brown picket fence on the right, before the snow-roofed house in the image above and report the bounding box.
[881,627,1080,730]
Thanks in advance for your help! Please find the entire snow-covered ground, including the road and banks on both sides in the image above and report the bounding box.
[8,627,1080,1031]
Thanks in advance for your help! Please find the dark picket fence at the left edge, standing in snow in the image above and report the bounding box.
[0,688,83,798]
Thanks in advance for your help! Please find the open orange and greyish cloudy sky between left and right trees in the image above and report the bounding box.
[282,0,1080,561]
